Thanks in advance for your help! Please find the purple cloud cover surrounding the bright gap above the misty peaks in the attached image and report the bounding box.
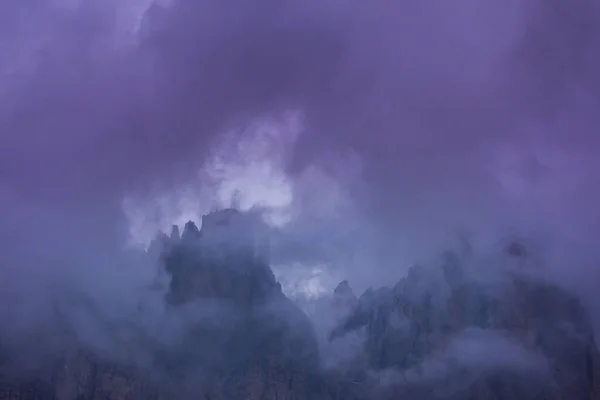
[0,0,600,344]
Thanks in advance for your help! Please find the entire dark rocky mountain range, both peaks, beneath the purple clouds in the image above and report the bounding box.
[0,210,600,400]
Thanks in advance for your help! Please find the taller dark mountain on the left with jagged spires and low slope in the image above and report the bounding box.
[0,210,329,400]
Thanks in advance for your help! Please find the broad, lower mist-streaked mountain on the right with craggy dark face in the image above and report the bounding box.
[330,244,600,400]
